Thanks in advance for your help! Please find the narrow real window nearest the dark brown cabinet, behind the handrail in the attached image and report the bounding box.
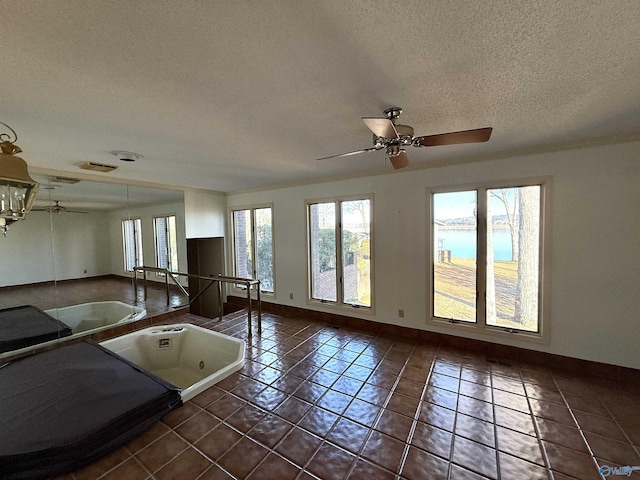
[232,207,274,293]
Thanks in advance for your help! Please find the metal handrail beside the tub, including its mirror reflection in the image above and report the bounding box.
[133,266,262,335]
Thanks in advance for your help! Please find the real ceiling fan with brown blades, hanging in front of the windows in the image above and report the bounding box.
[318,107,493,169]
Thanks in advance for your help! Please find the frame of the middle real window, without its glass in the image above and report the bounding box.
[305,193,375,314]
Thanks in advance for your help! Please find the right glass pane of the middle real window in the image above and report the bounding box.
[341,200,371,307]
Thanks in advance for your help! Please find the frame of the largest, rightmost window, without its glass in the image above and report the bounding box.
[426,177,551,344]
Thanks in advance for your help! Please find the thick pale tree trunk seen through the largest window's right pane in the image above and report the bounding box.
[514,187,540,325]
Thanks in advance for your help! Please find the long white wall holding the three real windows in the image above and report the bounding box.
[227,142,640,368]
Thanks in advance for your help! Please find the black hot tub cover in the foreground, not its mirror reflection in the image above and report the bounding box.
[0,340,182,480]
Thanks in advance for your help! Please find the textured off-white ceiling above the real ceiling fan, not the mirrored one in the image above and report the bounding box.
[0,0,640,192]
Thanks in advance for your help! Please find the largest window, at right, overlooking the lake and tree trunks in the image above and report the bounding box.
[430,182,544,333]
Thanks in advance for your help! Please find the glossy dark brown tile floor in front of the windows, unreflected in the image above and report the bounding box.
[47,312,640,480]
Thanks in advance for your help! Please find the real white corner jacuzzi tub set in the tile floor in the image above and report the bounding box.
[100,323,246,402]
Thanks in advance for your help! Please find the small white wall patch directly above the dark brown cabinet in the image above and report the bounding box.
[184,191,227,238]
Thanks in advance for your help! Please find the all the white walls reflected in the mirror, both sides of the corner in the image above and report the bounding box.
[0,197,187,287]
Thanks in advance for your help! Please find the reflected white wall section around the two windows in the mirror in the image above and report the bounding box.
[109,202,187,284]
